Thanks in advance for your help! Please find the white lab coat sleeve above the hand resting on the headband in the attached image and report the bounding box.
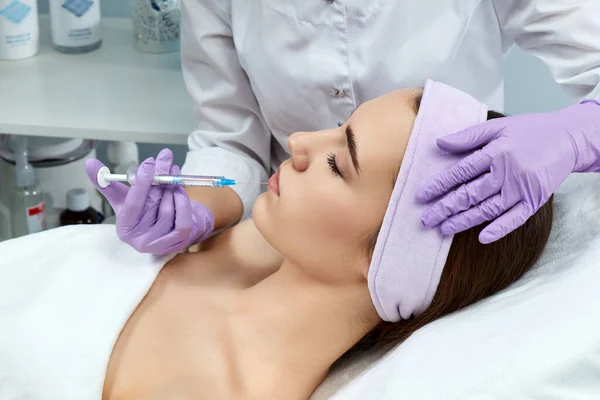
[493,0,600,100]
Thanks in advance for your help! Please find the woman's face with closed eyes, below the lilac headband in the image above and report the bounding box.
[253,89,422,282]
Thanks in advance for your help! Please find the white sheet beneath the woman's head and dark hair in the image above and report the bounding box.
[312,174,600,400]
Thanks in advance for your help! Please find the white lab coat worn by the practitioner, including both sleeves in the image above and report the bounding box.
[181,0,600,216]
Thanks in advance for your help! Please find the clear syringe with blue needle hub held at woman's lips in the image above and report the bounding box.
[97,167,266,188]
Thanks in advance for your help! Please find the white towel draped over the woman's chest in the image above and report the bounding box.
[0,225,168,400]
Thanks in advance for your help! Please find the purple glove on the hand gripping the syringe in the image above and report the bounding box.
[85,149,214,255]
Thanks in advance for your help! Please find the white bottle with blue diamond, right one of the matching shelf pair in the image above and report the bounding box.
[50,0,102,54]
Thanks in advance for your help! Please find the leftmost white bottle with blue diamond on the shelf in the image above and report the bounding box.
[0,0,40,60]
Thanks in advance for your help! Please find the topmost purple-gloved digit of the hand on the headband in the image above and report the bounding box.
[437,118,506,153]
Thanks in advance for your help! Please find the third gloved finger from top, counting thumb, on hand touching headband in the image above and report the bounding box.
[421,173,502,228]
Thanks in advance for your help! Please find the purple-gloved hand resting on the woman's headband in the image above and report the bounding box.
[417,100,600,243]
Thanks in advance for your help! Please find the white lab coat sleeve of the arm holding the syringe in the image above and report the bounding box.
[181,0,271,218]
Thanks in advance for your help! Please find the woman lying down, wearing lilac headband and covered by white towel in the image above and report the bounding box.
[0,81,552,400]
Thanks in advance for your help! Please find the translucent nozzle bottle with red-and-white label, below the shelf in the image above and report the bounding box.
[10,138,46,238]
